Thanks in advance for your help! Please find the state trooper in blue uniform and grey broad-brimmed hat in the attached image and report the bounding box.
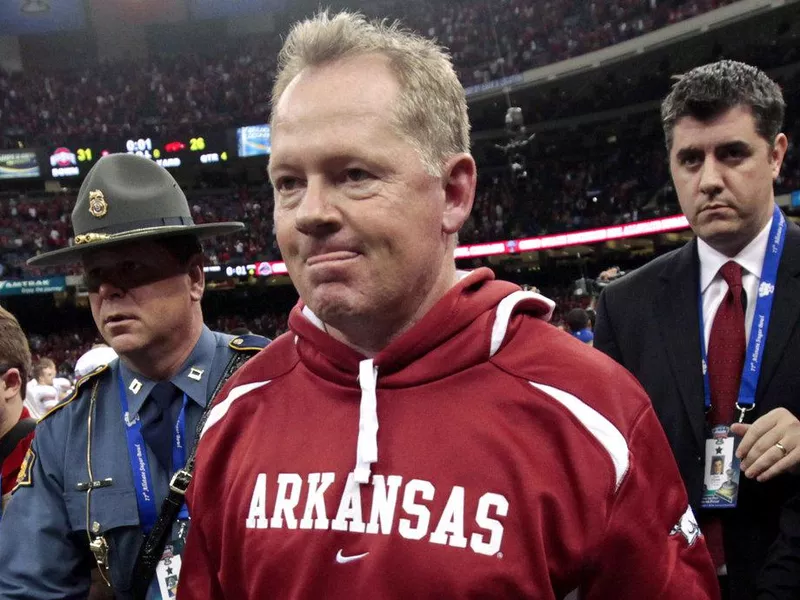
[0,154,268,600]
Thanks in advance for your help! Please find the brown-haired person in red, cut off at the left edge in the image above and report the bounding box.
[0,307,36,513]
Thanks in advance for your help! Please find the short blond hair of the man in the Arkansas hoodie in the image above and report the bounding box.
[272,11,469,176]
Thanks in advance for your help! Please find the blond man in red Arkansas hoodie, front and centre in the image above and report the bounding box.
[178,13,718,600]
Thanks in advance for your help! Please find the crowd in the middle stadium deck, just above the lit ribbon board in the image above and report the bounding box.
[6,100,800,277]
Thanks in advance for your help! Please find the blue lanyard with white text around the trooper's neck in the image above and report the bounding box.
[119,376,189,534]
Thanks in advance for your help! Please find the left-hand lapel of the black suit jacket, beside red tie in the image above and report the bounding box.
[656,240,705,447]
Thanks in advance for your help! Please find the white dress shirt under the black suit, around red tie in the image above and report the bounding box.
[697,219,772,350]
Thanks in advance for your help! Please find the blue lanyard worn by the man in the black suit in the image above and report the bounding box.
[698,205,786,423]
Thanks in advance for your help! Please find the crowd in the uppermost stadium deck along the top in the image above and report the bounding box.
[0,0,732,147]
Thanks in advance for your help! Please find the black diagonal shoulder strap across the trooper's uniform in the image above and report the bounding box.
[131,352,253,600]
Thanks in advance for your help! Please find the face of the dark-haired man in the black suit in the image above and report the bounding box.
[669,106,787,256]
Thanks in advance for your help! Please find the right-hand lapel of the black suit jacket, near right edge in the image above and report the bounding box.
[754,221,800,404]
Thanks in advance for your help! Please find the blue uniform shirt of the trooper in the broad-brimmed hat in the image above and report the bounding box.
[0,327,268,600]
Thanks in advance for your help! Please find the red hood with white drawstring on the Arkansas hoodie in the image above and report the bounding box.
[289,268,555,483]
